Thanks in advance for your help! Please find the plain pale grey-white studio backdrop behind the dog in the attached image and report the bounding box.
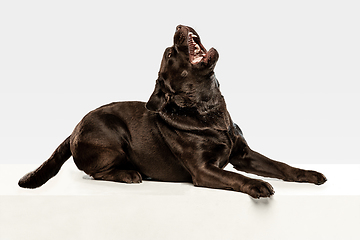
[0,0,360,164]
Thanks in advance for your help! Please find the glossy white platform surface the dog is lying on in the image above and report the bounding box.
[0,161,360,240]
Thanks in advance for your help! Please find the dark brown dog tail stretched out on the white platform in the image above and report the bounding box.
[18,137,72,188]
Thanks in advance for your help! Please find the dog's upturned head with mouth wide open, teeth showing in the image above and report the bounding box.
[146,25,221,111]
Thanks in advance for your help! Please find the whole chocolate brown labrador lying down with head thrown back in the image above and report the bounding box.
[19,25,326,198]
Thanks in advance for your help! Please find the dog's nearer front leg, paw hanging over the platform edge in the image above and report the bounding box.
[193,165,275,198]
